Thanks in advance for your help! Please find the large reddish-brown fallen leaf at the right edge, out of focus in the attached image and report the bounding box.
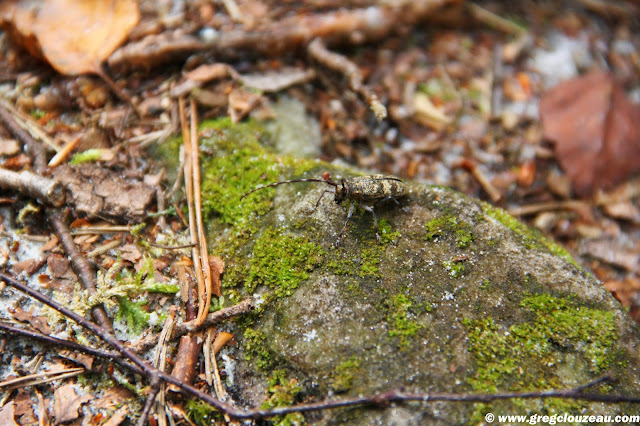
[540,72,640,196]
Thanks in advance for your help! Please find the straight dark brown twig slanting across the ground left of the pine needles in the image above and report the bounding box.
[49,213,113,332]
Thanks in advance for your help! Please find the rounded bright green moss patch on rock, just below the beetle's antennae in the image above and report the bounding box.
[245,229,323,297]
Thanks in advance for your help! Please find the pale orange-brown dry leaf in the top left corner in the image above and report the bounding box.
[0,0,140,75]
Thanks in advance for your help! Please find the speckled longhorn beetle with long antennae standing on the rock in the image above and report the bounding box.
[240,172,407,247]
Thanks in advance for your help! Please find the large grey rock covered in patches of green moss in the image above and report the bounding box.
[166,116,640,424]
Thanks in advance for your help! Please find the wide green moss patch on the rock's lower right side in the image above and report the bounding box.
[464,294,617,392]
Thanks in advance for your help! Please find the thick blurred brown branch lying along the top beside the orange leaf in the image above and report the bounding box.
[108,0,456,70]
